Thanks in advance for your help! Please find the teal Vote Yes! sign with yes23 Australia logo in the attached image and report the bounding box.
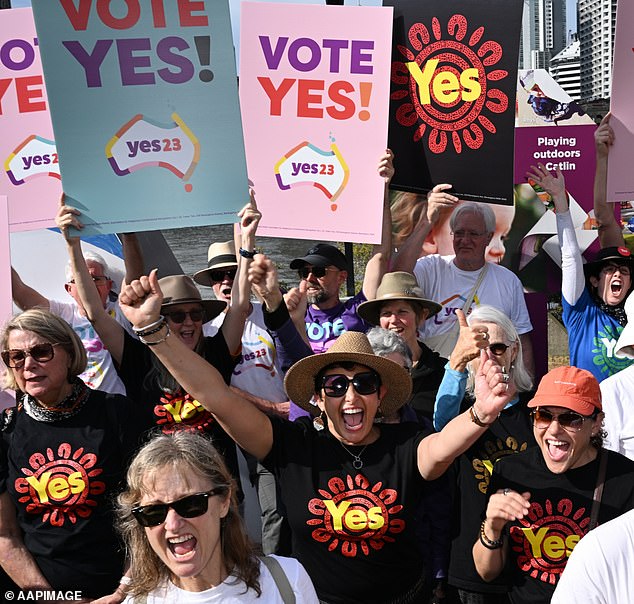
[33,0,248,234]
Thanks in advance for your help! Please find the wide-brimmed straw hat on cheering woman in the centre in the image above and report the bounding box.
[284,331,412,415]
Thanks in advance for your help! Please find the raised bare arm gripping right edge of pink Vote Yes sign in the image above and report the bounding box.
[362,149,394,300]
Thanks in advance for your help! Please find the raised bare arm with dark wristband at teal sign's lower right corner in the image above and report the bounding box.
[221,189,262,355]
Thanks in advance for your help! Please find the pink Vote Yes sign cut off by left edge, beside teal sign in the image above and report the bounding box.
[0,8,62,231]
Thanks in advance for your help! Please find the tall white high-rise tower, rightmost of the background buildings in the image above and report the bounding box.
[577,0,616,101]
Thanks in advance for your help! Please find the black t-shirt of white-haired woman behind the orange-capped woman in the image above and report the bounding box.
[449,393,536,593]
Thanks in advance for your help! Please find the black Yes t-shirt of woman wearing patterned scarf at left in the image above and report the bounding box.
[0,390,146,597]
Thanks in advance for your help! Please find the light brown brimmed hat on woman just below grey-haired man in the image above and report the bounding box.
[357,271,442,325]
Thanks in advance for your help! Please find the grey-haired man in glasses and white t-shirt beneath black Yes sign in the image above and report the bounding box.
[392,201,534,374]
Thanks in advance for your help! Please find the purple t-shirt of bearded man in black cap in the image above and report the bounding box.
[306,292,372,354]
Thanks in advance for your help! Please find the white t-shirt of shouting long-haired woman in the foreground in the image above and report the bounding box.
[123,556,319,604]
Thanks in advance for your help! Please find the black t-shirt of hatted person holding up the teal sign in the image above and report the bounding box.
[117,331,242,498]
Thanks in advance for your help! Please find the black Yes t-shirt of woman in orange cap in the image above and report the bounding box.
[489,447,634,604]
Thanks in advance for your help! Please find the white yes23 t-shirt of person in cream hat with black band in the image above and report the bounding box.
[203,302,288,403]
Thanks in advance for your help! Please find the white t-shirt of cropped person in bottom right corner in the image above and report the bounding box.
[551,510,634,604]
